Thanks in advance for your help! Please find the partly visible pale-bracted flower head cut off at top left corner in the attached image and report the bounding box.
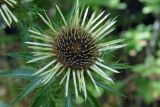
[0,0,18,27]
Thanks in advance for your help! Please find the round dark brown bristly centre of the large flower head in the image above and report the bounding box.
[54,28,98,70]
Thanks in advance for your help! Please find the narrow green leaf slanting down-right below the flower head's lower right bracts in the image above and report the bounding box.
[96,81,125,97]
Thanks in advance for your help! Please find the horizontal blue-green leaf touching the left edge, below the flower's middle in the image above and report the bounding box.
[0,69,33,78]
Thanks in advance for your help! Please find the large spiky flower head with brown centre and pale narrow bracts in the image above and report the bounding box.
[25,0,126,99]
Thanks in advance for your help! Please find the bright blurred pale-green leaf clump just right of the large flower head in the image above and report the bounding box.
[121,24,152,56]
